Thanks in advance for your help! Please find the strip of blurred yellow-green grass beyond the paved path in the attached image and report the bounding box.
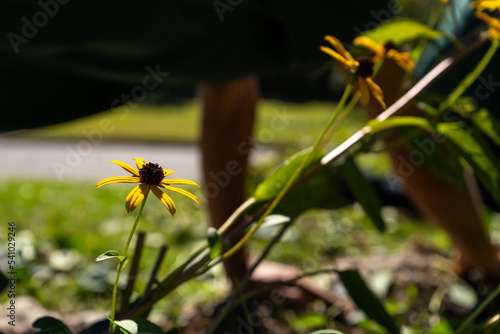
[21,100,365,145]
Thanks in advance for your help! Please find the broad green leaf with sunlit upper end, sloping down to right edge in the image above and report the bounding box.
[437,122,500,203]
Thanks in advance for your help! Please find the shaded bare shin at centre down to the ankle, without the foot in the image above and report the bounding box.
[199,77,260,284]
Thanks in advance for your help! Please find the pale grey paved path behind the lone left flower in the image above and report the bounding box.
[0,137,270,181]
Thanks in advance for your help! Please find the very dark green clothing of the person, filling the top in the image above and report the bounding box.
[0,0,392,130]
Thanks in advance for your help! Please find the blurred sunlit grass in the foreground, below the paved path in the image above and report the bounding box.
[0,180,449,322]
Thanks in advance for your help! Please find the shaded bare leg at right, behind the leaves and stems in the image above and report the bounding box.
[367,62,500,281]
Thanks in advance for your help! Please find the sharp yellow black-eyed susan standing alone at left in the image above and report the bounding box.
[95,159,200,216]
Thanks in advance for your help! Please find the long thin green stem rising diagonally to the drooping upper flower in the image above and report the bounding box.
[222,74,357,260]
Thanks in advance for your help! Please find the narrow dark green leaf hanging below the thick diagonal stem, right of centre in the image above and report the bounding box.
[338,156,386,232]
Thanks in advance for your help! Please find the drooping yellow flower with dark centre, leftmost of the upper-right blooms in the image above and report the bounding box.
[320,36,387,109]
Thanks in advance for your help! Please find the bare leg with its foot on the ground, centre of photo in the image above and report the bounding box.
[199,77,352,310]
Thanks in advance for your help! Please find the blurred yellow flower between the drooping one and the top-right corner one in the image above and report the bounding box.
[352,36,415,72]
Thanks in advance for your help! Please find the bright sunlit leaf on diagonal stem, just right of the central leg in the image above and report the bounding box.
[253,148,322,202]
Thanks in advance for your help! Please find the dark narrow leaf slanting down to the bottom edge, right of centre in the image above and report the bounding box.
[338,270,400,334]
